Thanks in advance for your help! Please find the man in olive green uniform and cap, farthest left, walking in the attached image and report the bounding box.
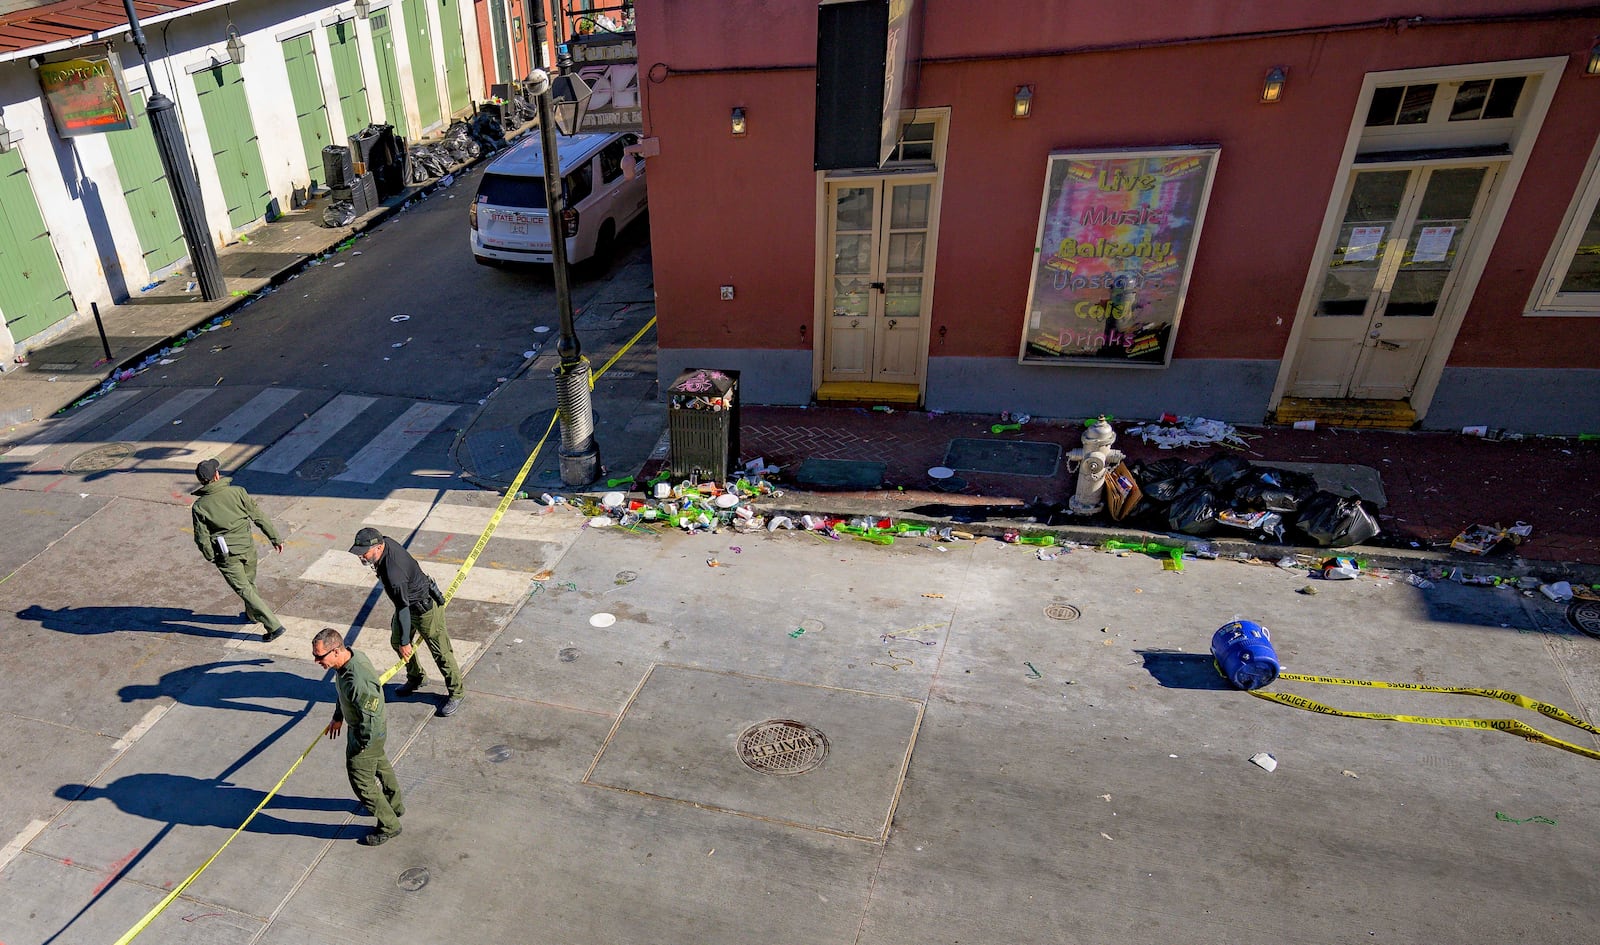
[190,459,283,643]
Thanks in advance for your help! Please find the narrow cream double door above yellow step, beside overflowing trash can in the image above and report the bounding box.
[822,177,933,384]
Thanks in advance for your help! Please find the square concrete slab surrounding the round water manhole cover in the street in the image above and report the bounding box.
[584,664,922,843]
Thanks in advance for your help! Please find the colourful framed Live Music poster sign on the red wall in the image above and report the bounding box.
[1018,147,1221,368]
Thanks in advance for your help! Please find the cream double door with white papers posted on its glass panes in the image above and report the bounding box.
[1290,165,1499,400]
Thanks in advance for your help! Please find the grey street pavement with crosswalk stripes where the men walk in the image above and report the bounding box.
[0,171,1600,945]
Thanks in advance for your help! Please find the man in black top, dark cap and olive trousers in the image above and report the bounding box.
[350,528,467,716]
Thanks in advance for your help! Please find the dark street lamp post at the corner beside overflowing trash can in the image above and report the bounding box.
[528,58,600,486]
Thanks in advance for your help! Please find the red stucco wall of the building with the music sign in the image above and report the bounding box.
[637,0,1600,366]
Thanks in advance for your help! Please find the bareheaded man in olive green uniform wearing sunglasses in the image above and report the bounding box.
[310,627,405,846]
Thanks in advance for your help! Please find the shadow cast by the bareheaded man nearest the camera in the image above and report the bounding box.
[56,772,360,839]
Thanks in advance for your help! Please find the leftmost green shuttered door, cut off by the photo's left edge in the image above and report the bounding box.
[0,149,74,341]
